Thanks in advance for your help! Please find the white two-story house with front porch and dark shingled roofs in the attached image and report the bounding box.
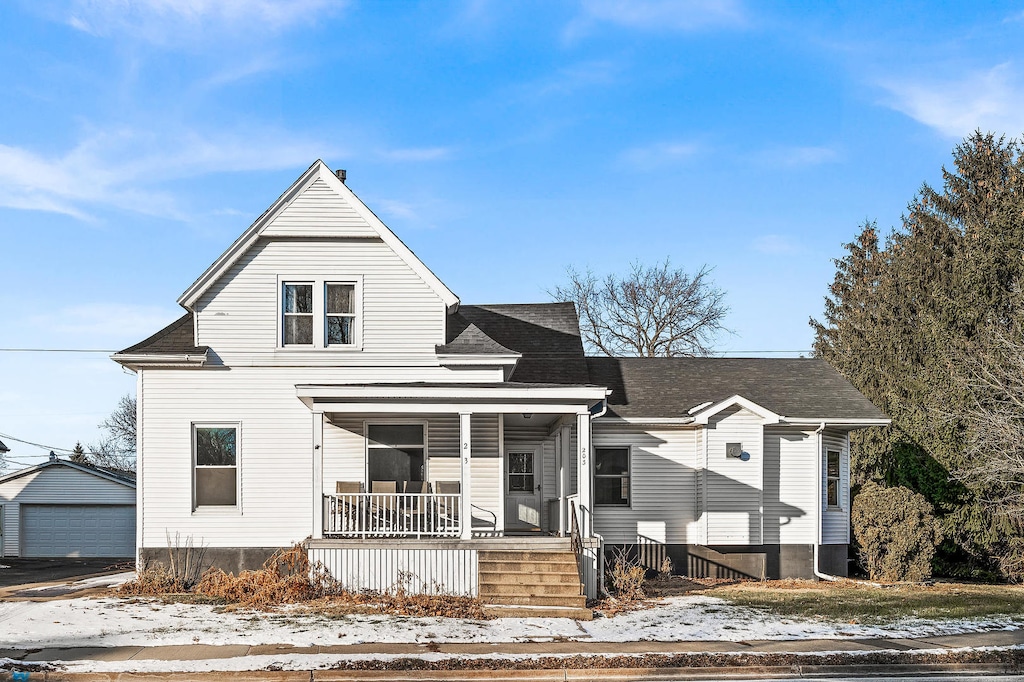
[114,161,888,604]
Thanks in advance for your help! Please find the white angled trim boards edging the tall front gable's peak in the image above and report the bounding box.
[178,159,459,311]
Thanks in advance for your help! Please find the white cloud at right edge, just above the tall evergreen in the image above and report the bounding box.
[880,62,1024,138]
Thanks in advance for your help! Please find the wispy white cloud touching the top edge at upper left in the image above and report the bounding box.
[63,0,346,45]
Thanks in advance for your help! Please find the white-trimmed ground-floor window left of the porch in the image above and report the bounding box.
[193,424,239,509]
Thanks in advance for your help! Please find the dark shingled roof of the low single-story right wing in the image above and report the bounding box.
[587,357,886,420]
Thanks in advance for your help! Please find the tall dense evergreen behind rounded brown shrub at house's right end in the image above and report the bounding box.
[811,132,1024,574]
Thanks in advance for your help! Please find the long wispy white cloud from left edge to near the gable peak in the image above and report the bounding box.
[0,129,337,220]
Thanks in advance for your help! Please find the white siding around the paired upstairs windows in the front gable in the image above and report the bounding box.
[196,240,445,360]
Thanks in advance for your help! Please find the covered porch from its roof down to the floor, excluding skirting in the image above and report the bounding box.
[296,383,604,540]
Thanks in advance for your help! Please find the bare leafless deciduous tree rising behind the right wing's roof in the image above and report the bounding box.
[548,259,729,357]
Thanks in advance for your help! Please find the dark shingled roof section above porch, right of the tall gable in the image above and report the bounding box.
[437,303,588,384]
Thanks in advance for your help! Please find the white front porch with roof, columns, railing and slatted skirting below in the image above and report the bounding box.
[297,384,604,596]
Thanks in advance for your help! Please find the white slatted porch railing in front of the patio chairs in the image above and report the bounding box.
[324,493,462,538]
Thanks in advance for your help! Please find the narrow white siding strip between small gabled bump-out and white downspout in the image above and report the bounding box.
[764,427,817,545]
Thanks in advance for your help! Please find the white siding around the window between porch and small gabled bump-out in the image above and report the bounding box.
[594,421,697,545]
